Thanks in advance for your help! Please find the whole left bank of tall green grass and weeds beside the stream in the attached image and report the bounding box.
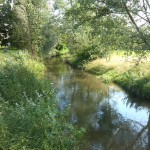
[0,52,82,150]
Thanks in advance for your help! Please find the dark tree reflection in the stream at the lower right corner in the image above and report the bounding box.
[81,92,150,150]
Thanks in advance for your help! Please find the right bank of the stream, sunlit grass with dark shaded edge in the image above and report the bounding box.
[61,51,150,100]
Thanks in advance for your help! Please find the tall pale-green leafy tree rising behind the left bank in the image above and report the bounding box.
[11,0,48,55]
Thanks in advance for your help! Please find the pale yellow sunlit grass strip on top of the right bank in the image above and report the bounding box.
[84,52,150,76]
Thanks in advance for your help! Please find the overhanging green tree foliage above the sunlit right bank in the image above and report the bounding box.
[64,0,149,59]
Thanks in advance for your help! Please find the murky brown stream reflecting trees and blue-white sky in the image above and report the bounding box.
[47,59,150,150]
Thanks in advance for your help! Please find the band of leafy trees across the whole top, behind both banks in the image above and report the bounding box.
[0,0,150,56]
